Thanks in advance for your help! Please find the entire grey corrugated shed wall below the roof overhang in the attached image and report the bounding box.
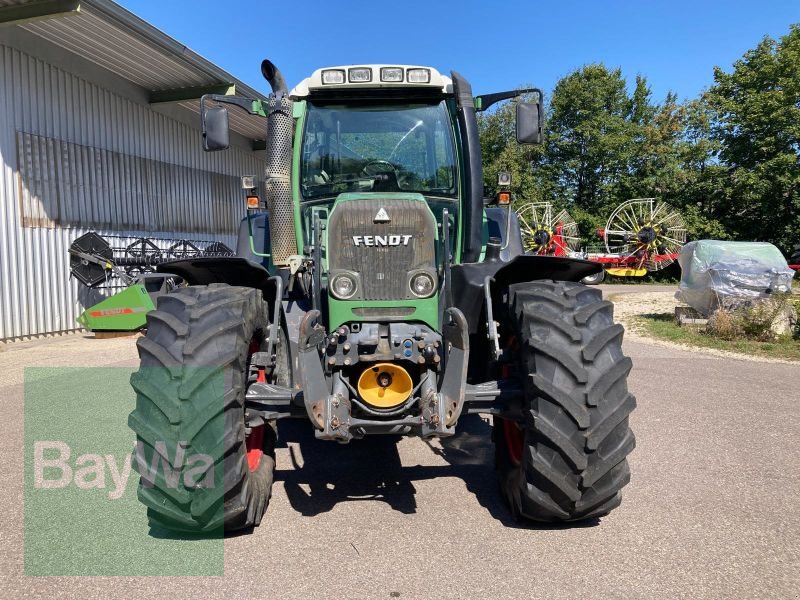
[0,45,262,340]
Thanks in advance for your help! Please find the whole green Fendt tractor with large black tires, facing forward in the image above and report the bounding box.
[129,60,635,532]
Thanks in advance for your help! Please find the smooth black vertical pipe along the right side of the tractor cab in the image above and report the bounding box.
[450,71,483,262]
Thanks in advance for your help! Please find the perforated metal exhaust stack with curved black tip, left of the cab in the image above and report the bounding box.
[261,60,298,266]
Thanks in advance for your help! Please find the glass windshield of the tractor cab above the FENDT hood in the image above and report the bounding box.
[301,101,457,200]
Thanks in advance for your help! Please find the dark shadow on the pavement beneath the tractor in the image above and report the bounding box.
[275,415,597,530]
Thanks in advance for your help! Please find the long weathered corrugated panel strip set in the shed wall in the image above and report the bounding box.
[17,131,241,234]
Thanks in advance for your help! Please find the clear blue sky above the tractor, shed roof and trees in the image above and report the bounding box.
[118,0,800,100]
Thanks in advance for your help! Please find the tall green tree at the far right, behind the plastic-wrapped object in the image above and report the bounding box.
[703,24,800,252]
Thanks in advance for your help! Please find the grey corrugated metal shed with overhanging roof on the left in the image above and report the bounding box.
[0,0,264,342]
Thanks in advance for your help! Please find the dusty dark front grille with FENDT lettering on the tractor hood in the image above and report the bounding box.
[327,198,436,300]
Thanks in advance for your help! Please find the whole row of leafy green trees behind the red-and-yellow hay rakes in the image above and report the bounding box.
[479,25,800,251]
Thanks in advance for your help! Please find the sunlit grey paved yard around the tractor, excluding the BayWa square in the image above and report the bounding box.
[0,286,800,600]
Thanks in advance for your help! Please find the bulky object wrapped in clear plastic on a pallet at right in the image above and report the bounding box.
[675,240,794,316]
